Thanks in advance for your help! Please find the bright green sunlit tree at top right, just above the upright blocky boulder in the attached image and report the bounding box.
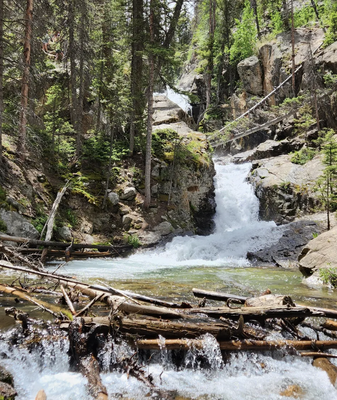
[230,0,257,64]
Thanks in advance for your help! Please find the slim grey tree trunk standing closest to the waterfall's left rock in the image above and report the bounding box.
[144,0,154,209]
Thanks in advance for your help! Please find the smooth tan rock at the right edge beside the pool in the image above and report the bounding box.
[298,226,337,278]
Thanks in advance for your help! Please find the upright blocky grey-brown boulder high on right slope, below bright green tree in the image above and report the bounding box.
[238,56,263,96]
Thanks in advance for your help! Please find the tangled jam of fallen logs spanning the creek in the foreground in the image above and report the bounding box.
[0,261,337,399]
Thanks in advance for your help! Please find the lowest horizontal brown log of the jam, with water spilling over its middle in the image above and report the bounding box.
[135,339,337,351]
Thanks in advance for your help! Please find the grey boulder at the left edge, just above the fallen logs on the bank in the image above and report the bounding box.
[0,210,39,239]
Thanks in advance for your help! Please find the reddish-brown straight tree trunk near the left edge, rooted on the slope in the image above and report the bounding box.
[17,0,33,160]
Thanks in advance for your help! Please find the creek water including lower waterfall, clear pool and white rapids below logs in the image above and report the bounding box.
[0,160,337,400]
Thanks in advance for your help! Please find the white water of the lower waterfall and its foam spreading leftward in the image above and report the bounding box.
[58,160,282,279]
